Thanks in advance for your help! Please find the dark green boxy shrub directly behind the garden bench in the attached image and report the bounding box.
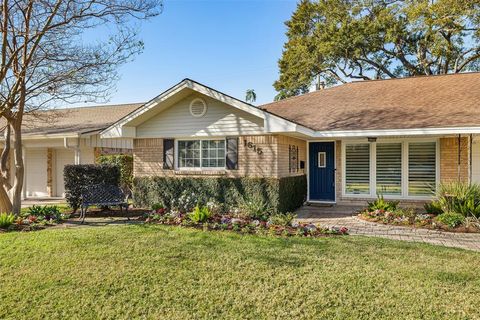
[64,164,120,212]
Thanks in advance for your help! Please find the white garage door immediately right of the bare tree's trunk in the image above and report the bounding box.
[25,149,48,197]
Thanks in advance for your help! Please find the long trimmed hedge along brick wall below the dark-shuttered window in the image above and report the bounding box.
[133,175,307,212]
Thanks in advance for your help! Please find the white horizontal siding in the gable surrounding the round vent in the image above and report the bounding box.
[137,95,264,138]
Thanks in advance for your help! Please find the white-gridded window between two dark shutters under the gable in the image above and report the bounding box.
[177,139,225,169]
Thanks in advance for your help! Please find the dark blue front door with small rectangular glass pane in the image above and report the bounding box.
[308,142,335,201]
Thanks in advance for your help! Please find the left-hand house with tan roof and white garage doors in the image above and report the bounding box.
[6,104,142,199]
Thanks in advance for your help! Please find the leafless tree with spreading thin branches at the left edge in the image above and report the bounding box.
[0,0,161,213]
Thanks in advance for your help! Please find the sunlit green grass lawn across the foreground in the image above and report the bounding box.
[0,225,480,319]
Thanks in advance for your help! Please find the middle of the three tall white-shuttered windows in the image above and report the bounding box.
[376,143,402,195]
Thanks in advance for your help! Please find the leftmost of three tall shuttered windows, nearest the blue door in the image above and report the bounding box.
[345,143,370,194]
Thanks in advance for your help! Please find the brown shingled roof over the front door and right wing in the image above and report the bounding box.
[260,73,480,132]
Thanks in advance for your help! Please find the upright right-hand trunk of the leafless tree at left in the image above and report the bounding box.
[12,116,24,214]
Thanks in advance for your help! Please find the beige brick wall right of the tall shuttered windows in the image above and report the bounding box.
[440,137,469,182]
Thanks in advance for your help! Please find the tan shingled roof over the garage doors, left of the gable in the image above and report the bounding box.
[18,103,143,136]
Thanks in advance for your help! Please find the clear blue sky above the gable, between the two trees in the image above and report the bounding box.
[99,0,296,104]
